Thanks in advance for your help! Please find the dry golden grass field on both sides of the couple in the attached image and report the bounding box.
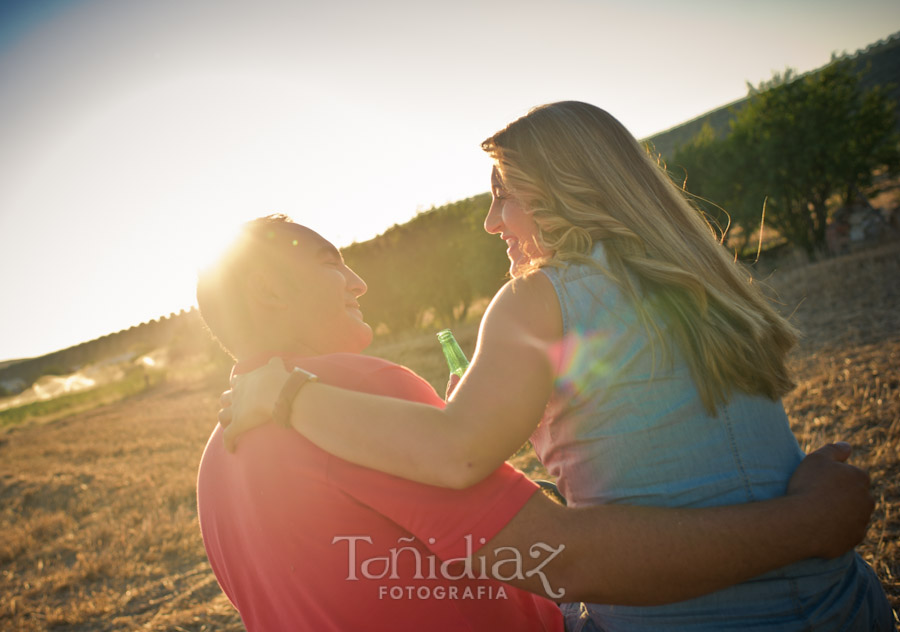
[0,243,900,631]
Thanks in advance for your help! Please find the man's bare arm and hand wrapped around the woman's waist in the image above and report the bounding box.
[475,444,874,605]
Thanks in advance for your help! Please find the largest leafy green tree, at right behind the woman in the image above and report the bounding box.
[726,61,900,259]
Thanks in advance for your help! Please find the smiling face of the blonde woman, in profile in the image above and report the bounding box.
[484,167,551,276]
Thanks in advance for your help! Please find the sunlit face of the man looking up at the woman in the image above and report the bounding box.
[271,224,372,354]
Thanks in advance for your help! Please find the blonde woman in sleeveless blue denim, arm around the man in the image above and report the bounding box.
[226,102,893,630]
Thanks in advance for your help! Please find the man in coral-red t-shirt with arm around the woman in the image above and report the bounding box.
[197,216,872,632]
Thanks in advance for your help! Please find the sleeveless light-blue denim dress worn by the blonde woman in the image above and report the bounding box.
[532,244,894,632]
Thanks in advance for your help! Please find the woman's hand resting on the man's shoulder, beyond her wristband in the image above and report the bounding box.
[219,358,290,452]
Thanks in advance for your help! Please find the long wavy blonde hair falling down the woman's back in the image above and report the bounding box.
[481,101,797,413]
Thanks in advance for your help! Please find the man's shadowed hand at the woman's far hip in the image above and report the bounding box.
[787,442,875,559]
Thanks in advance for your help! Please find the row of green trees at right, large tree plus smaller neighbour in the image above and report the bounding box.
[668,60,900,259]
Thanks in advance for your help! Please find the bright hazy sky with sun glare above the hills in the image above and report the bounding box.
[0,0,900,360]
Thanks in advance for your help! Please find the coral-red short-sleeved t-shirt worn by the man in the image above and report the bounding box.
[197,354,563,632]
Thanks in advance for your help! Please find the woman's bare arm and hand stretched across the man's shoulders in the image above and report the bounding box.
[225,273,562,488]
